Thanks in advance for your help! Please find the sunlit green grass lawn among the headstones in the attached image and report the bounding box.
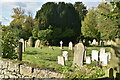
[23,46,110,70]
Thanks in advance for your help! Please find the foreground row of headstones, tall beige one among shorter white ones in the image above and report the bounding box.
[58,43,111,66]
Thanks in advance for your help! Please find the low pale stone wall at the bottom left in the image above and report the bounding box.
[0,59,63,79]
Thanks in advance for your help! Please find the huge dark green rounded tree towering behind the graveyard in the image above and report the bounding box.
[33,2,86,44]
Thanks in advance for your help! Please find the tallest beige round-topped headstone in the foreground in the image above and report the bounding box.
[73,43,85,67]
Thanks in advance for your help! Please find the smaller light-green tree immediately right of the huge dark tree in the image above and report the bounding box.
[81,8,100,40]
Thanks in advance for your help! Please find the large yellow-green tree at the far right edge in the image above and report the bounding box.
[97,3,120,40]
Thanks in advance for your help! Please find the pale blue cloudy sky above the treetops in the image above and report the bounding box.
[0,0,103,25]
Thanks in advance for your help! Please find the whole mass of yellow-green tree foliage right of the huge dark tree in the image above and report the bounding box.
[82,2,120,40]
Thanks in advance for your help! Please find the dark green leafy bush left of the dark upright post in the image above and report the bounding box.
[2,26,18,59]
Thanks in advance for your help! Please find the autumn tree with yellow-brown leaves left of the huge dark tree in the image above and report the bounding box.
[10,7,33,39]
